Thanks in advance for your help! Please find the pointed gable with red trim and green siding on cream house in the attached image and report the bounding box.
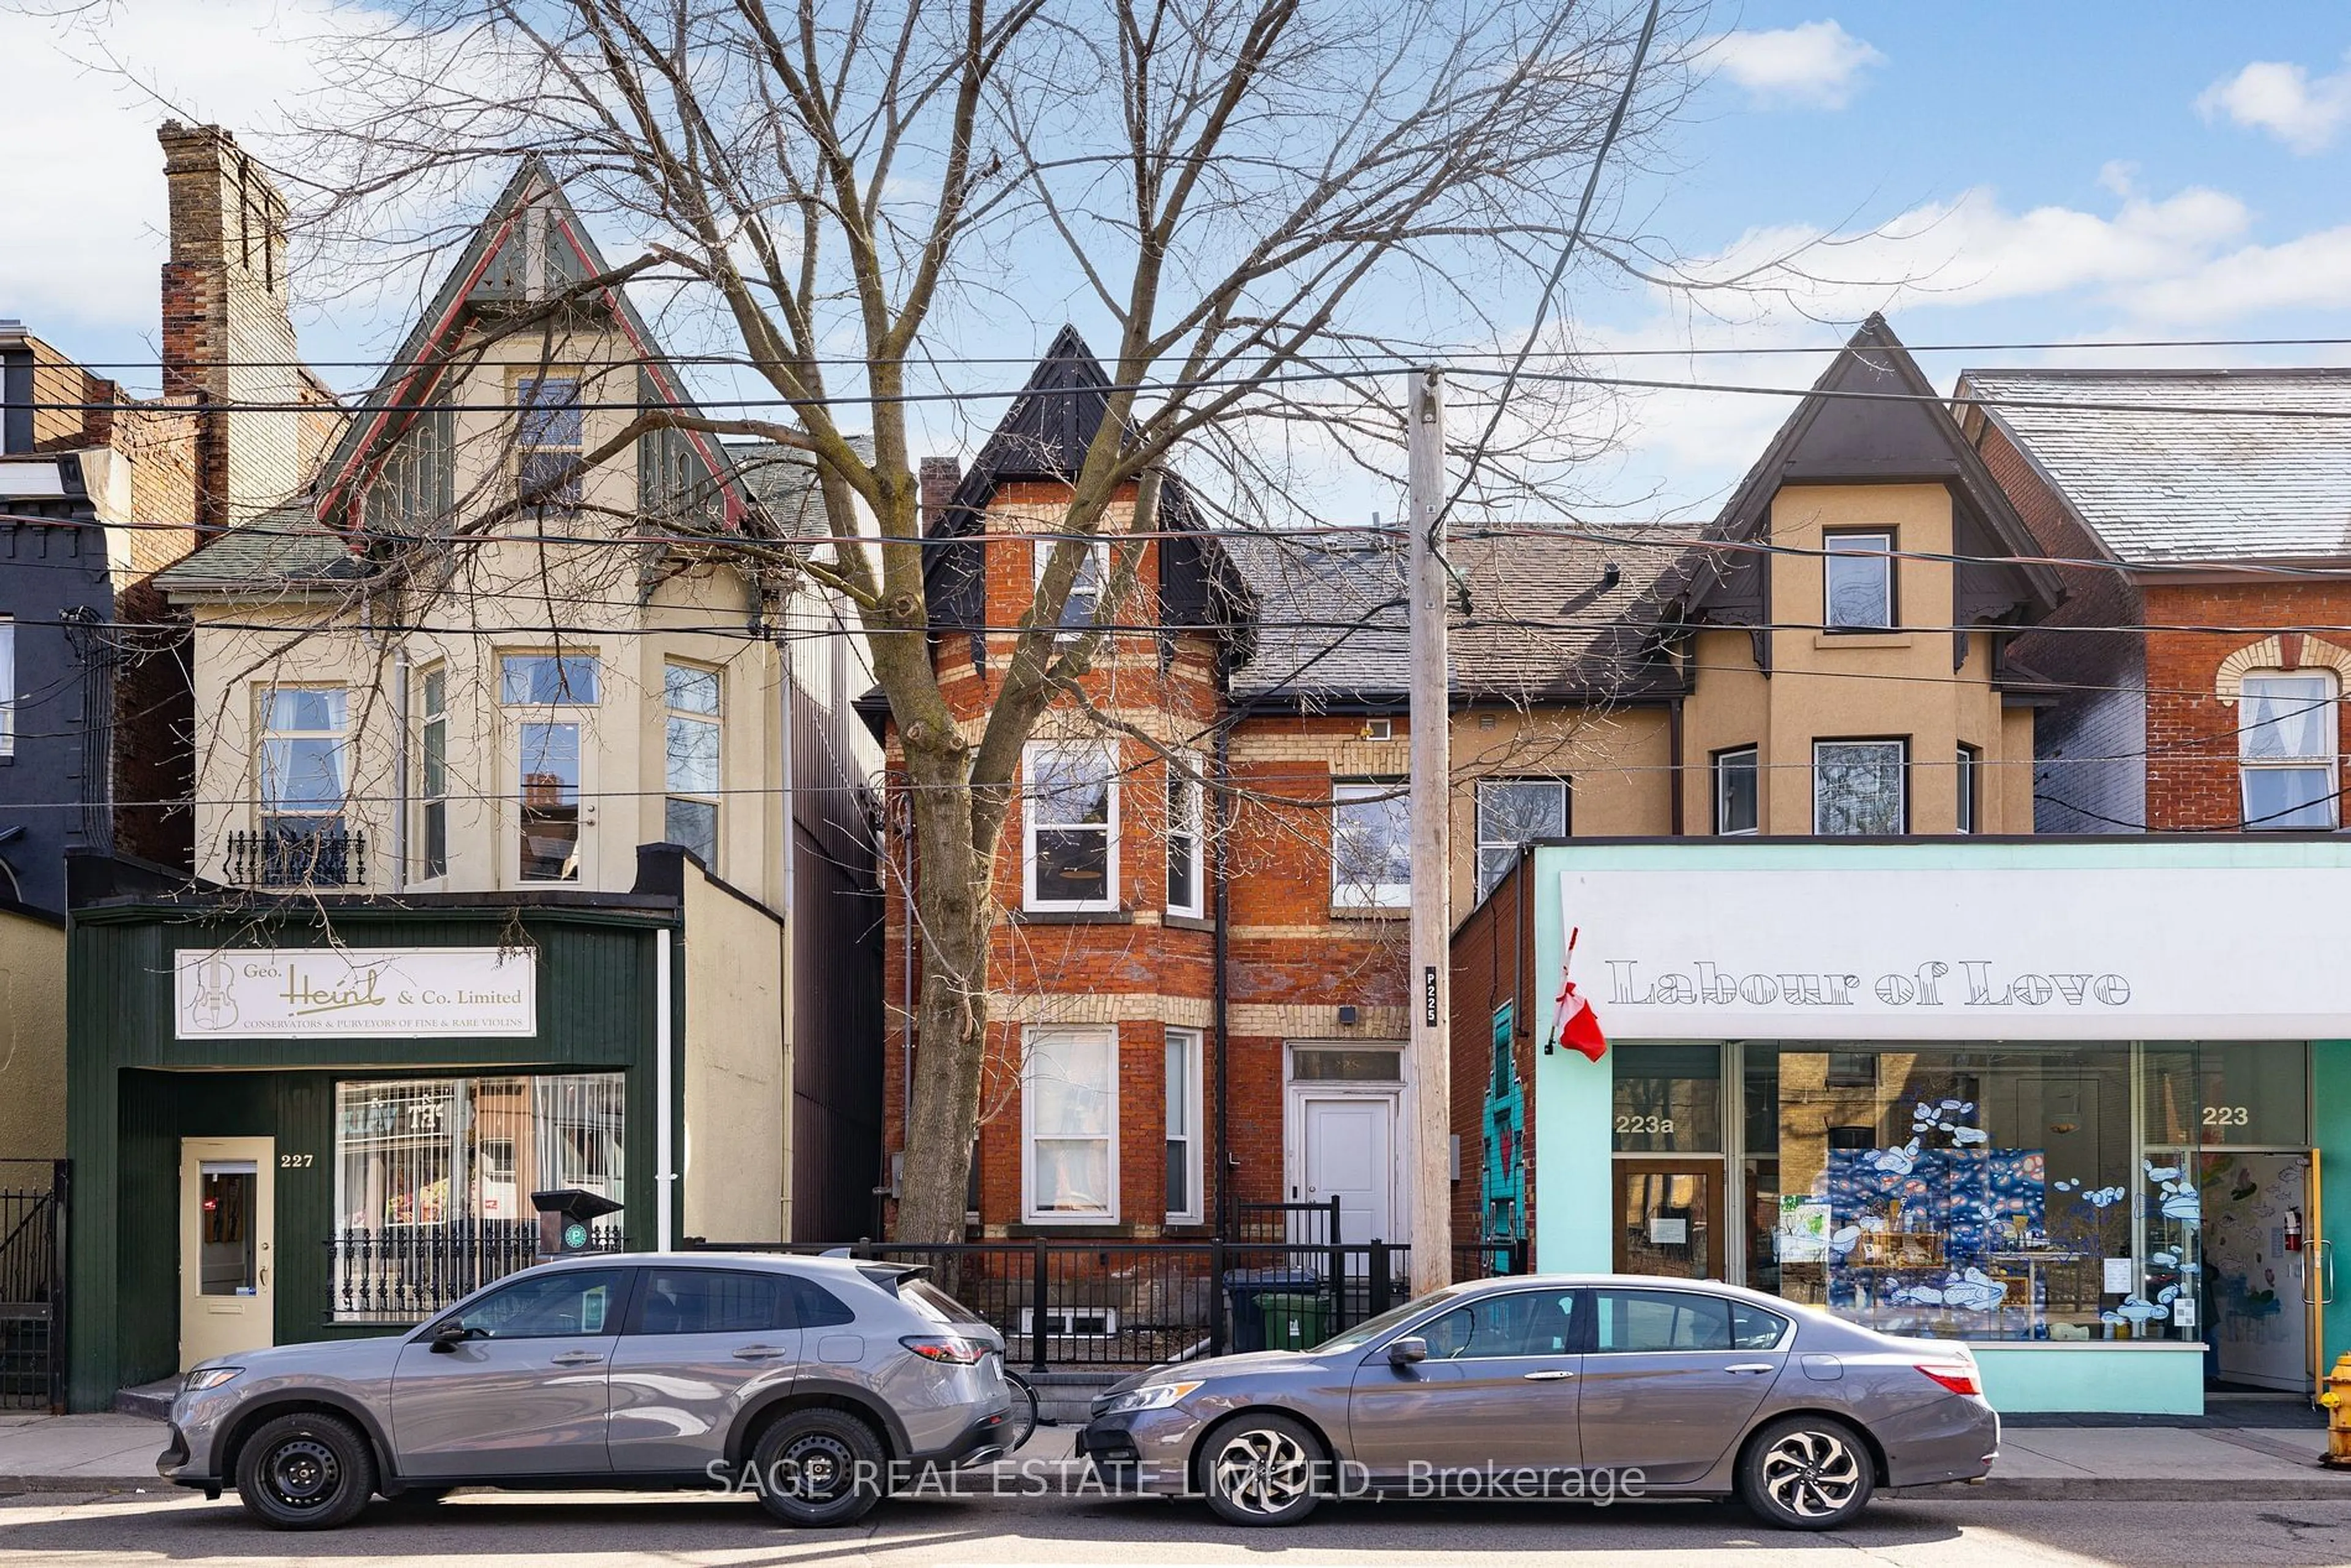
[315,155,752,536]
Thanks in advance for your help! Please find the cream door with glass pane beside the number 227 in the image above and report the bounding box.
[179,1138,277,1370]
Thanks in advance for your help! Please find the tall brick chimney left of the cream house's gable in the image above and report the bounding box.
[155,120,303,527]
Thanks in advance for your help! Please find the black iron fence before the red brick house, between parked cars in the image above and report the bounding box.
[686,1237,1526,1373]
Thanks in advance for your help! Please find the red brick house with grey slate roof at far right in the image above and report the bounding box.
[1959,369,2351,832]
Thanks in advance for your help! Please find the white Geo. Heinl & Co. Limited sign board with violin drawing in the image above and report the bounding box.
[171,947,538,1039]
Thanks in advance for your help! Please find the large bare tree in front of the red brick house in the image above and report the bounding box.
[266,0,1702,1239]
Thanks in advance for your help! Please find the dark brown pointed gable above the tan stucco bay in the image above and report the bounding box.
[1671,315,2062,628]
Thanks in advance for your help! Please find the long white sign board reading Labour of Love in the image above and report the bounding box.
[1561,868,2351,1039]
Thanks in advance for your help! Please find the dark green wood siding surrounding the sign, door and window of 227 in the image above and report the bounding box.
[66,910,682,1411]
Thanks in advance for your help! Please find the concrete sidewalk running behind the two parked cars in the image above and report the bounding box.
[18,1415,2351,1502]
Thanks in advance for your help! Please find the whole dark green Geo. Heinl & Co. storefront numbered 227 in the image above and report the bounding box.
[68,891,684,1411]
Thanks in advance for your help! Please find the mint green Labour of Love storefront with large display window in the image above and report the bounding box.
[1521,837,2351,1413]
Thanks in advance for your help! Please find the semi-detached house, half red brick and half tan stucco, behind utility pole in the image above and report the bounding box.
[865,320,2055,1244]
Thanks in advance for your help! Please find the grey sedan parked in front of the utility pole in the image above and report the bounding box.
[1079,1277,2001,1531]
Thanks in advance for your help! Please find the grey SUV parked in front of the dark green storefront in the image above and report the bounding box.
[155,1253,1011,1531]
